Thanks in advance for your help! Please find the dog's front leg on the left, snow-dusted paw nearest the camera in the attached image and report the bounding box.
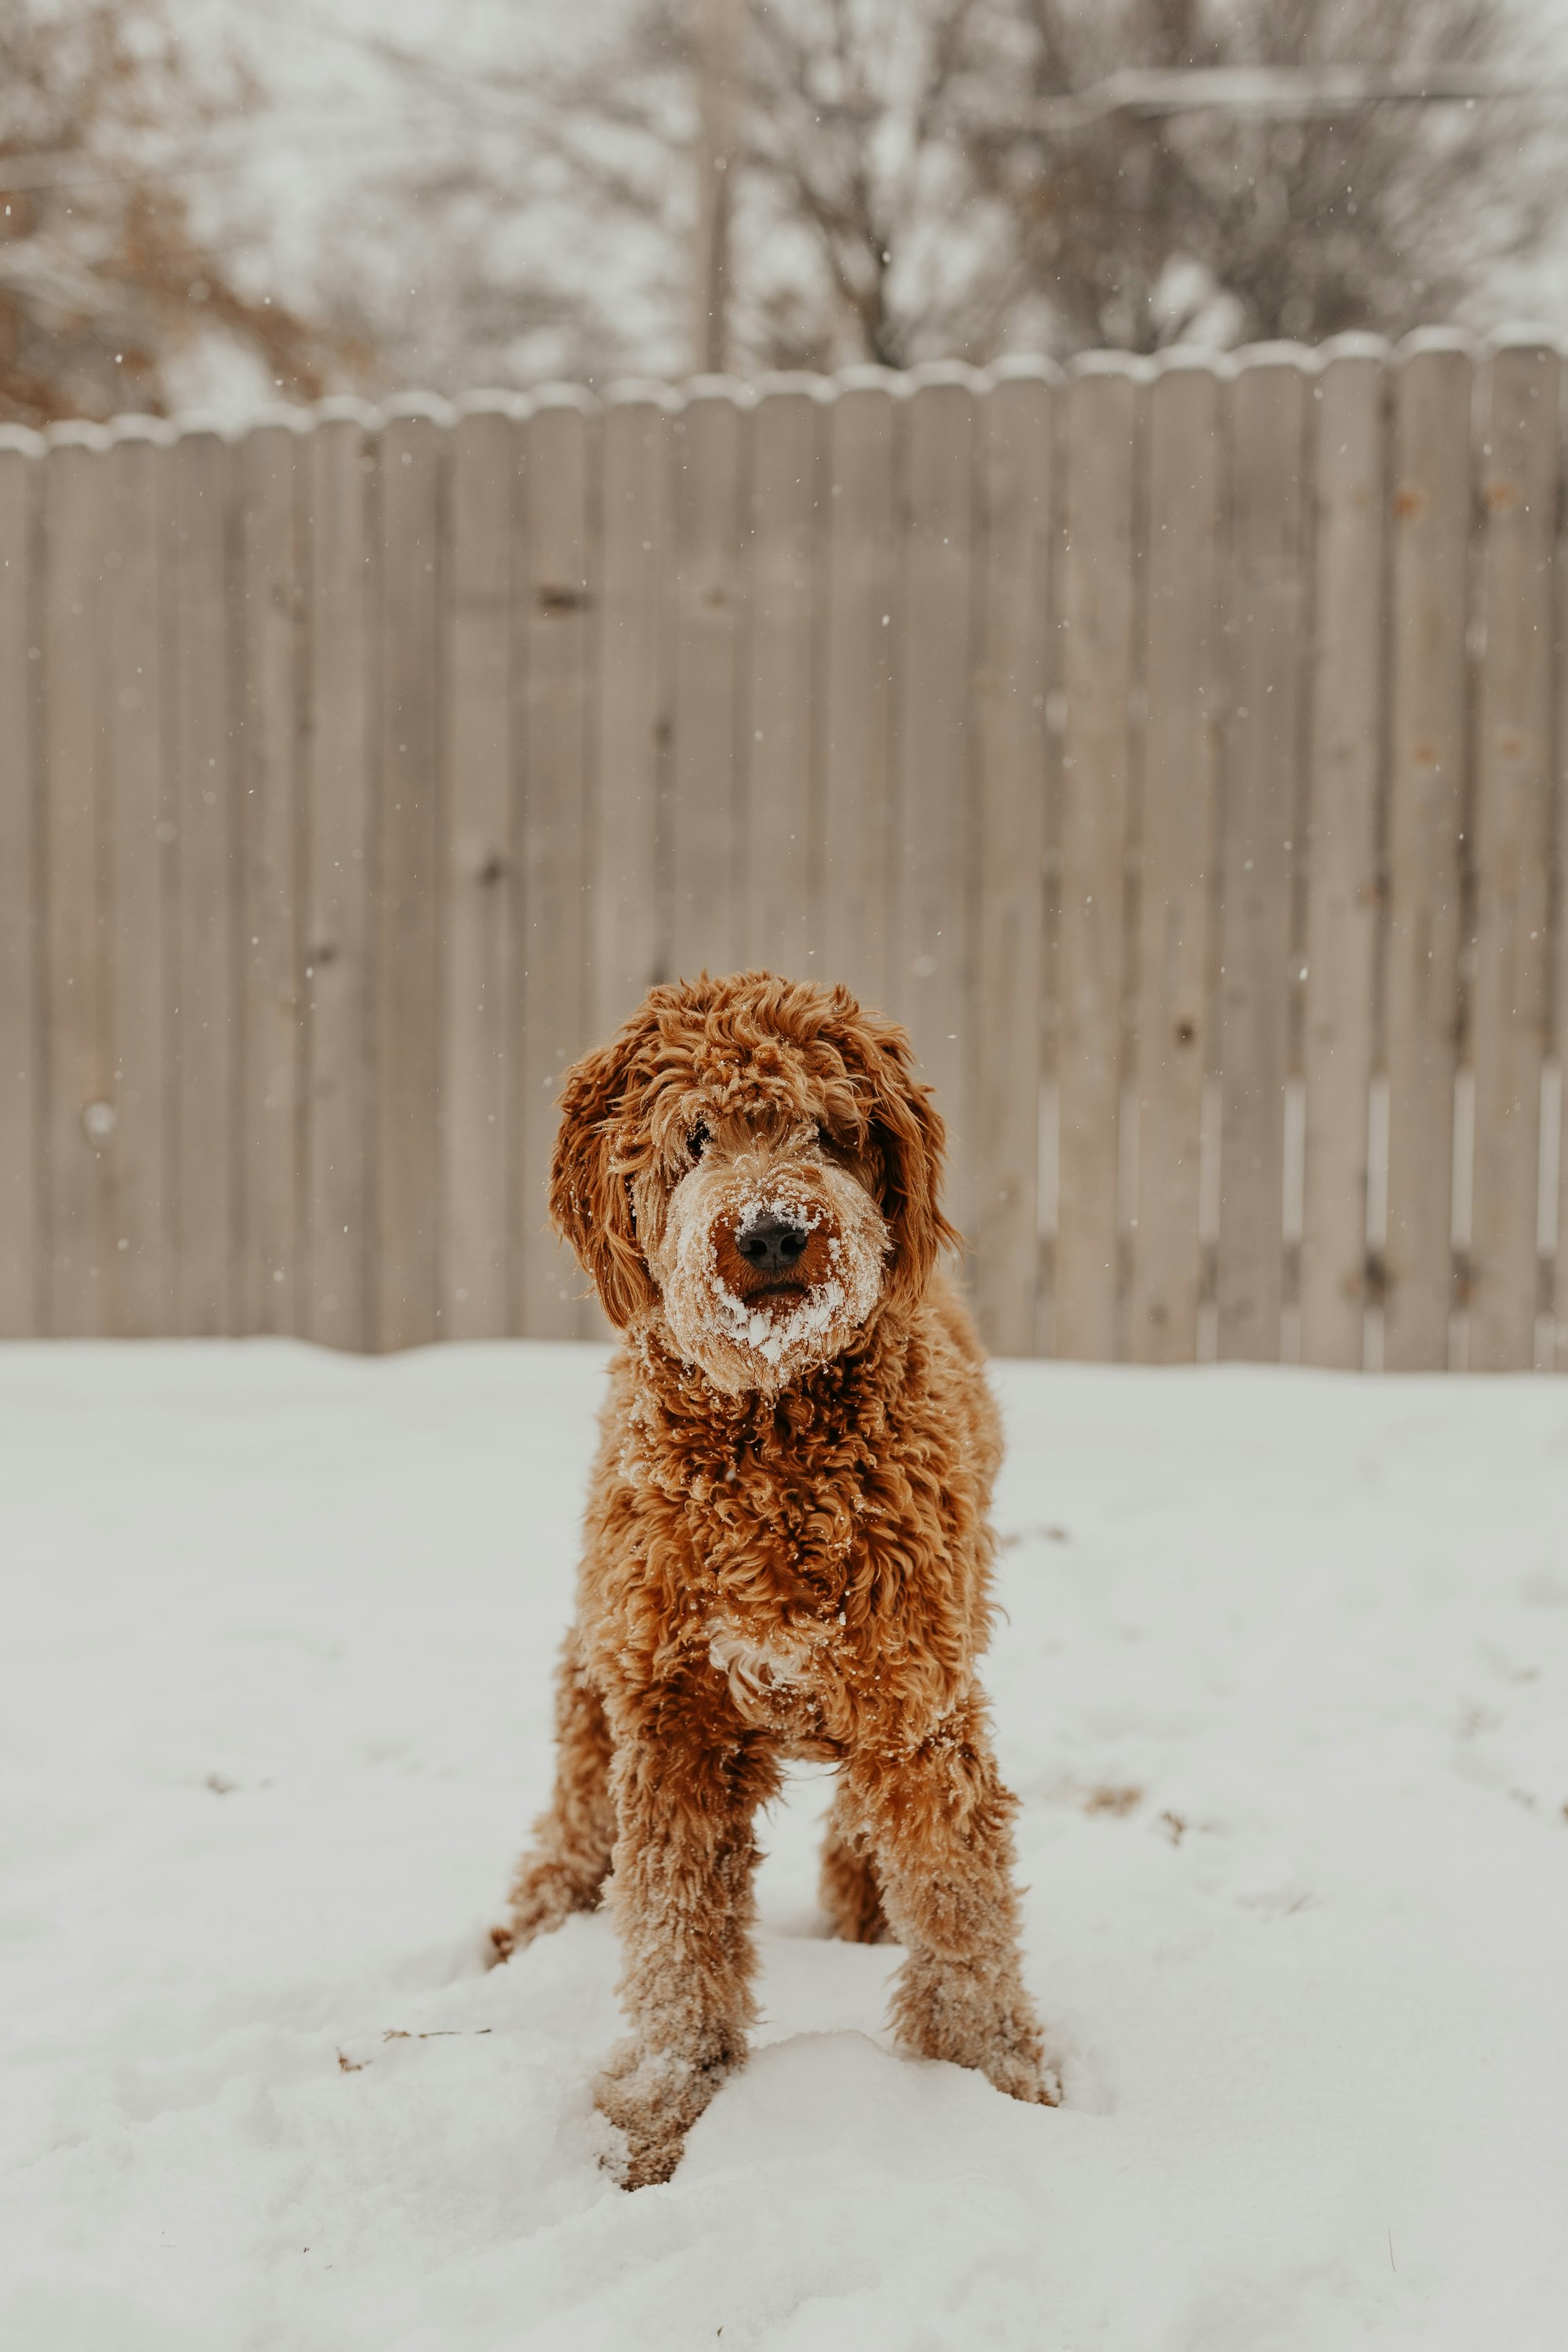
[597,1693,779,2190]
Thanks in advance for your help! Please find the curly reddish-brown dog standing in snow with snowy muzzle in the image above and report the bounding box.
[494,971,1058,2187]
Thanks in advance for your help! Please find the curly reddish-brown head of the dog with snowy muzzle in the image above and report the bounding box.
[550,971,956,1395]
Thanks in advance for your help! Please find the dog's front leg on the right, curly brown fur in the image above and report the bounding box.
[848,1698,1060,2105]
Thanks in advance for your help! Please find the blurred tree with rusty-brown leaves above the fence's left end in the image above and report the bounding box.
[0,0,338,423]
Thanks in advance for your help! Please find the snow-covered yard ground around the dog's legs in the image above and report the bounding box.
[0,1341,1568,2352]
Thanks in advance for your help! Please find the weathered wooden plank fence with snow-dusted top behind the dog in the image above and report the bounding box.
[0,334,1568,1369]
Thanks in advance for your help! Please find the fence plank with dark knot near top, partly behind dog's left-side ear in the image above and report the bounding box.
[524,393,606,1338]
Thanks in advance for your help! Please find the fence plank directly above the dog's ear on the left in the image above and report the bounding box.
[593,386,675,1035]
